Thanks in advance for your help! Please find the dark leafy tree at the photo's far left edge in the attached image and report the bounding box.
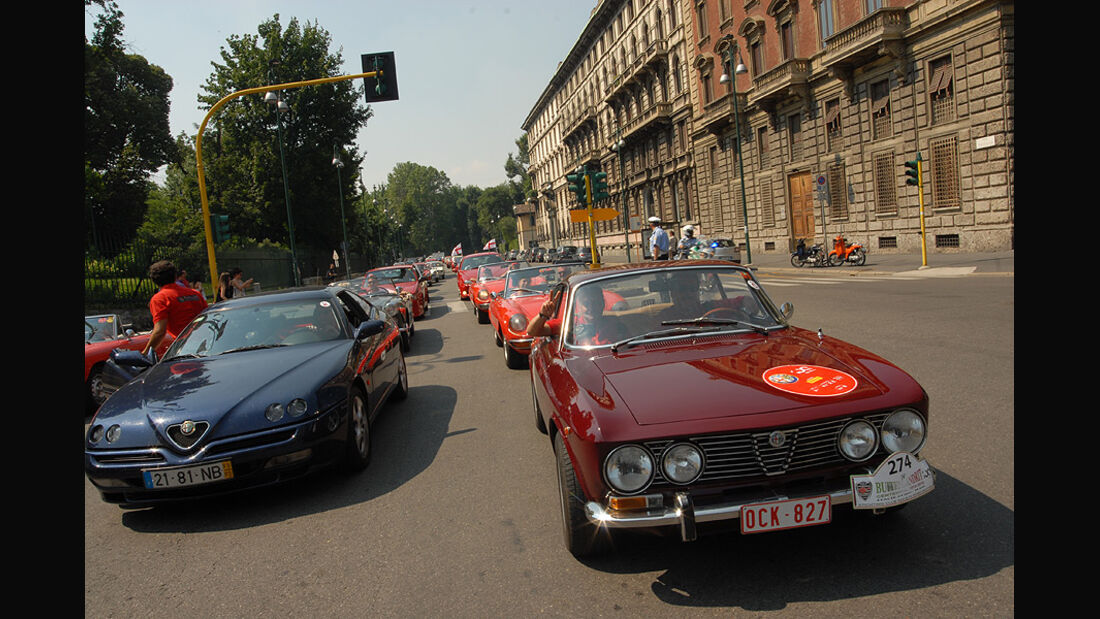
[84,0,175,251]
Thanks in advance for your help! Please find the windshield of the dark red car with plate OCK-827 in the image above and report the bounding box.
[562,266,783,346]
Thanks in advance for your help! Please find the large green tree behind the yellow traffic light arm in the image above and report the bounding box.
[198,13,372,261]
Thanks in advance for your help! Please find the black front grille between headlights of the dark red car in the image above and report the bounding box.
[645,412,889,486]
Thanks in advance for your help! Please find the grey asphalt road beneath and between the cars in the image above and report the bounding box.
[84,270,1015,618]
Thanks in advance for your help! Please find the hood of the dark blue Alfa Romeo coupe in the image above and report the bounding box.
[94,340,352,449]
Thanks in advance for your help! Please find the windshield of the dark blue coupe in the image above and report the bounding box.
[165,299,344,358]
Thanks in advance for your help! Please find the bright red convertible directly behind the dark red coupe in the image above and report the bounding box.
[488,264,587,369]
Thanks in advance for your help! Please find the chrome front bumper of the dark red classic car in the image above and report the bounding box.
[584,488,851,542]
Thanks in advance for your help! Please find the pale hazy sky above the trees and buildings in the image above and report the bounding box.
[85,0,596,188]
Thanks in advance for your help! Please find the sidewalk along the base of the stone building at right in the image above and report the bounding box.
[604,250,1015,276]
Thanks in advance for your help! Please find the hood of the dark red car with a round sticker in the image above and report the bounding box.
[585,328,923,428]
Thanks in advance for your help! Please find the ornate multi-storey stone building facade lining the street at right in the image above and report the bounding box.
[524,0,1014,259]
